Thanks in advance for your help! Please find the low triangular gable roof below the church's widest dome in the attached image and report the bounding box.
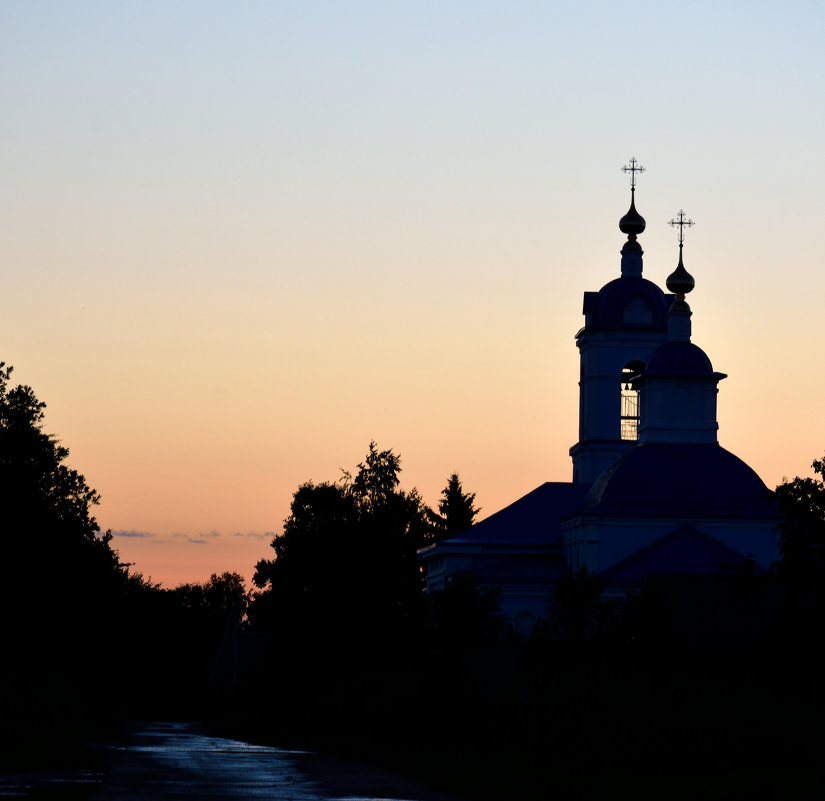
[599,526,765,584]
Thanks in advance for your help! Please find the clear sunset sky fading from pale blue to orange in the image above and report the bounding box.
[0,0,825,586]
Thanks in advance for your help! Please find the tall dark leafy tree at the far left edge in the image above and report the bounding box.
[0,363,135,643]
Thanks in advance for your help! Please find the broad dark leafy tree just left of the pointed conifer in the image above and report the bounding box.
[250,442,431,642]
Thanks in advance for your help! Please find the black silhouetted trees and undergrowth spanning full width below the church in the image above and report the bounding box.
[0,365,825,798]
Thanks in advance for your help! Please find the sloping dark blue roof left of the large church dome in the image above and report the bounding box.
[446,481,590,545]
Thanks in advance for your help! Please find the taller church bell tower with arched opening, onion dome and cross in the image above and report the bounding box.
[570,158,672,483]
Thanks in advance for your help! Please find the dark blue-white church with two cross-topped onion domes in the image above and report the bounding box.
[420,159,779,633]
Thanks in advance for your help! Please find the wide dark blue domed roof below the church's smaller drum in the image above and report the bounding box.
[585,442,773,518]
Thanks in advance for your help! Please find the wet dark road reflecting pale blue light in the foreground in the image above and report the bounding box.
[91,723,464,801]
